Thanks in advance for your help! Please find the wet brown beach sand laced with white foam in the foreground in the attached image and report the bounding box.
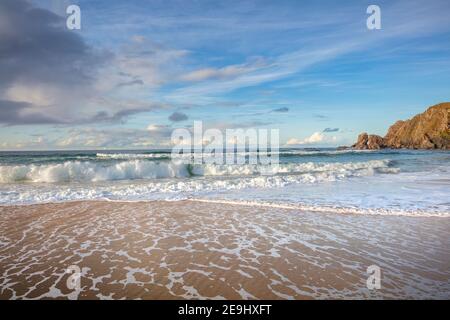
[0,200,450,299]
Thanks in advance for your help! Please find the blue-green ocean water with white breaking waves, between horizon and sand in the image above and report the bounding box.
[0,149,450,216]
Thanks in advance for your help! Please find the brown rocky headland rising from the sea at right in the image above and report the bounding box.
[352,102,450,150]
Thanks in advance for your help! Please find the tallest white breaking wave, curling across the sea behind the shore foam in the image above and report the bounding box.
[0,159,398,183]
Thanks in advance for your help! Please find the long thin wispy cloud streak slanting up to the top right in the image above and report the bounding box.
[169,1,450,103]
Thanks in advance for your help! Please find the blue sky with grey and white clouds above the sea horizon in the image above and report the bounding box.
[0,0,450,150]
